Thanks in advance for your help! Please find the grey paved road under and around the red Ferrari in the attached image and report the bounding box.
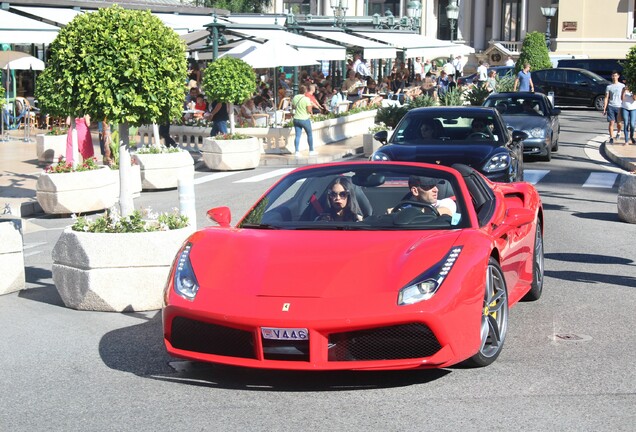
[0,110,636,431]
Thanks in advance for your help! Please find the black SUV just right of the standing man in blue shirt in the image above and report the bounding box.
[531,68,610,111]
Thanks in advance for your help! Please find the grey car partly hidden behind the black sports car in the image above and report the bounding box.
[484,92,561,161]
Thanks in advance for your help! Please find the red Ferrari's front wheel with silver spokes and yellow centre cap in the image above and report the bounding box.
[464,257,508,367]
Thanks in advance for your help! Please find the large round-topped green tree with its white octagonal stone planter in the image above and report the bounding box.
[38,5,194,311]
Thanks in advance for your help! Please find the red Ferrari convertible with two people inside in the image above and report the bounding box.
[163,162,543,370]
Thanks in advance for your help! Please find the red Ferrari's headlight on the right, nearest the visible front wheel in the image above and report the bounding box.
[398,246,462,306]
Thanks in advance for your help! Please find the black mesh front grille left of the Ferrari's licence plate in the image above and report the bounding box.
[170,317,256,359]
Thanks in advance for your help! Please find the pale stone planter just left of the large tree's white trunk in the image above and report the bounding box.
[36,166,119,214]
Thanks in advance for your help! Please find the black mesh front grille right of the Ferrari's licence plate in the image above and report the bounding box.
[329,323,441,361]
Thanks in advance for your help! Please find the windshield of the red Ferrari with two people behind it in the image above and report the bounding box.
[239,165,468,230]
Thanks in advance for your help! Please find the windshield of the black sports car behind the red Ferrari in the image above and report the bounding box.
[391,110,505,145]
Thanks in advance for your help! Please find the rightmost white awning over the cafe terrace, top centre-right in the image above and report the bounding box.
[354,31,475,60]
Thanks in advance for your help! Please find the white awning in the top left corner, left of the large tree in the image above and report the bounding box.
[0,10,60,44]
